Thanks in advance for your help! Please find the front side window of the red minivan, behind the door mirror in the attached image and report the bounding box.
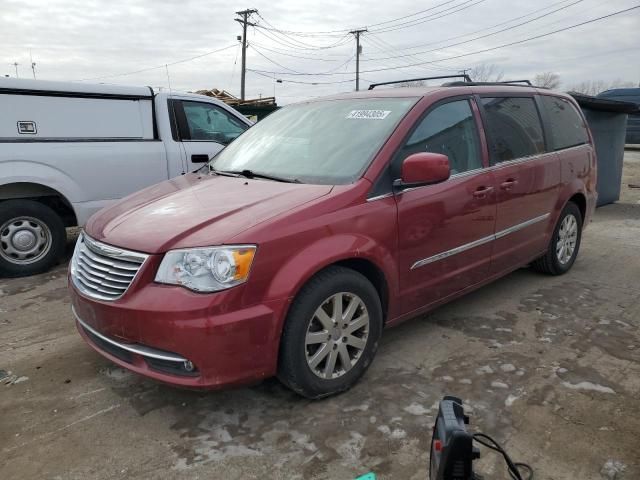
[392,100,482,178]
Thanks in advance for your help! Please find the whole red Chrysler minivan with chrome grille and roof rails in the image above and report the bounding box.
[69,84,596,398]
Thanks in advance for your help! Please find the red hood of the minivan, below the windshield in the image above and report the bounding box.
[85,174,332,253]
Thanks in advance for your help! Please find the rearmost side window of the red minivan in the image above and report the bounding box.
[540,95,589,150]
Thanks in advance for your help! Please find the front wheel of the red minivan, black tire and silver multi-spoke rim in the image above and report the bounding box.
[278,267,382,399]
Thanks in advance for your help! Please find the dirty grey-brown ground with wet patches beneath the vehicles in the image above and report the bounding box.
[0,151,640,480]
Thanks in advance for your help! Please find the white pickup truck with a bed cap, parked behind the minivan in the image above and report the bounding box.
[0,78,251,277]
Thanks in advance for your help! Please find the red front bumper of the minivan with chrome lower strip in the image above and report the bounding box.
[69,282,287,388]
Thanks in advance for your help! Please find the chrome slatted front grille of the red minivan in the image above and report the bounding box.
[71,234,148,300]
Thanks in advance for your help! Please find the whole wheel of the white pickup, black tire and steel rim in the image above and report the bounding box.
[0,200,67,277]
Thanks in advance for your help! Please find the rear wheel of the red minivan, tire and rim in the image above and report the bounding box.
[531,202,582,275]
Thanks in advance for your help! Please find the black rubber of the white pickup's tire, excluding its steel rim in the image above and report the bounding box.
[0,200,66,278]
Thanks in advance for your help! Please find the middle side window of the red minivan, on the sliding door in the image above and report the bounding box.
[482,97,545,163]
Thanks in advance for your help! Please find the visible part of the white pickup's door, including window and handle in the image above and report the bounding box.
[172,100,249,172]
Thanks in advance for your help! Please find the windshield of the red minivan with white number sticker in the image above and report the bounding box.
[211,98,417,185]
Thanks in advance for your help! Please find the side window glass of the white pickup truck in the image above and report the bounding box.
[182,101,248,145]
